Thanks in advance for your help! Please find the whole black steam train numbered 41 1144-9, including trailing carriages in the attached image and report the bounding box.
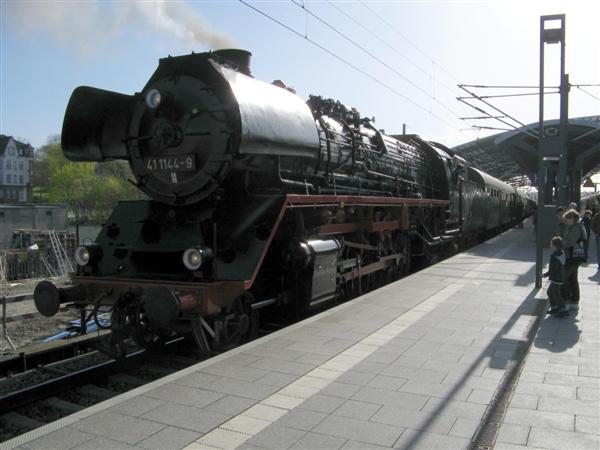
[34,49,527,353]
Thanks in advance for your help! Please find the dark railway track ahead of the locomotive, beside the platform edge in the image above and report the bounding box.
[0,338,201,442]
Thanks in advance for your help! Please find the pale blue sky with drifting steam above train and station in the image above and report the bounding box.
[0,0,600,147]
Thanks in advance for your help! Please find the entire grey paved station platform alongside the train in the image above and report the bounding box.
[0,227,600,450]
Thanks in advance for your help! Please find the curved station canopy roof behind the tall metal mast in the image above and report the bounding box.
[452,116,600,186]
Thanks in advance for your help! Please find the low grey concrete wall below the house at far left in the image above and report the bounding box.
[0,204,68,248]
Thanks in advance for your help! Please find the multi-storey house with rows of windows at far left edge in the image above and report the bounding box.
[0,134,33,203]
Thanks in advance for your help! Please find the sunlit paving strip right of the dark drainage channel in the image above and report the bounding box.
[496,241,600,450]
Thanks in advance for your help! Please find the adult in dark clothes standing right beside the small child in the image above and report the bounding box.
[562,209,587,311]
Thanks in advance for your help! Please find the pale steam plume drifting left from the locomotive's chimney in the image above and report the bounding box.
[2,0,235,58]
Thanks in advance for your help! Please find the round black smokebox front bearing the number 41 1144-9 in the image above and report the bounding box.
[129,72,232,205]
